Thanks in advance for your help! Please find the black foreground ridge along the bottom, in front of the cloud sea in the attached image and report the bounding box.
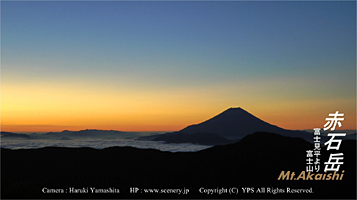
[1,132,356,199]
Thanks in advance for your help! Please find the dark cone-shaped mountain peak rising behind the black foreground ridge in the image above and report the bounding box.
[141,108,312,145]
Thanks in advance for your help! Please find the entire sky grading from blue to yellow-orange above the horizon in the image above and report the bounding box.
[1,1,356,132]
